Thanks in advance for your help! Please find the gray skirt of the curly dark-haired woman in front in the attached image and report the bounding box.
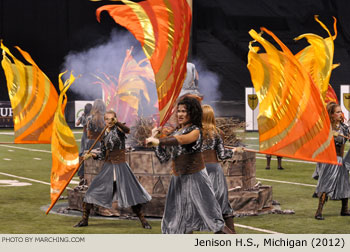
[161,169,224,234]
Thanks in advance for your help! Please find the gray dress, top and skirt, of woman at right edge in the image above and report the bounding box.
[313,124,350,200]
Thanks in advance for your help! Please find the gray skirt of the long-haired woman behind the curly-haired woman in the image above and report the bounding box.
[205,163,233,217]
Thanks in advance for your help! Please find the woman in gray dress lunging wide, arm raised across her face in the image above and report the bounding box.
[74,110,151,229]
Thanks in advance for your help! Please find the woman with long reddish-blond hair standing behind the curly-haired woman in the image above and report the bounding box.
[202,105,236,233]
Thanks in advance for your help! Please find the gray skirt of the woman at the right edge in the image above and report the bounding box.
[316,155,350,200]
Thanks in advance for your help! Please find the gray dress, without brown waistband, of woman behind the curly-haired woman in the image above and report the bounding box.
[202,132,233,218]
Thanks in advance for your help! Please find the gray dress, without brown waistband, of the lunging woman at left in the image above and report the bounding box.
[84,126,152,208]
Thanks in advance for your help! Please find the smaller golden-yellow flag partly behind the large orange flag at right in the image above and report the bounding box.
[295,15,337,100]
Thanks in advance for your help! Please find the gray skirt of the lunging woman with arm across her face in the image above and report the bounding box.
[84,162,152,208]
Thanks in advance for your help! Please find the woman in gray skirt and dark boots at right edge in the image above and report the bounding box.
[315,103,350,220]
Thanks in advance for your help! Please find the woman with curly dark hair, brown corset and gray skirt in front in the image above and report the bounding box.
[146,97,232,234]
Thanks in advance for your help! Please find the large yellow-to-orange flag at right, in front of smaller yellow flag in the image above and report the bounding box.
[248,28,337,164]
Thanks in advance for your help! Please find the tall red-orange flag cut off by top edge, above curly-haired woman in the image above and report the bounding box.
[96,0,192,125]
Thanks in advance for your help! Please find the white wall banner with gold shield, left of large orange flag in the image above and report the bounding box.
[245,88,259,131]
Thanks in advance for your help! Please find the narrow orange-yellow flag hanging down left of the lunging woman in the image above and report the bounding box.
[46,73,79,214]
